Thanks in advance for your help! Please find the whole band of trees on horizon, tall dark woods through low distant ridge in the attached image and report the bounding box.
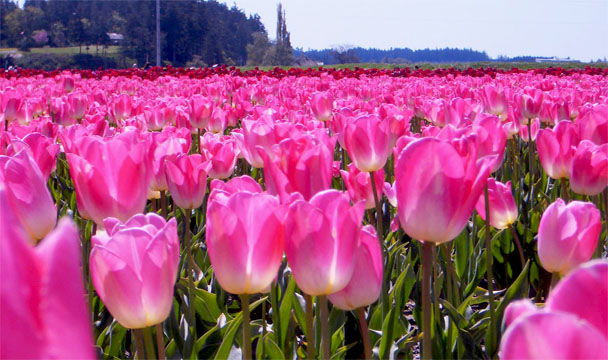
[0,0,552,68]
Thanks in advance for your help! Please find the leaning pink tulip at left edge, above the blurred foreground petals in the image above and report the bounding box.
[0,150,57,242]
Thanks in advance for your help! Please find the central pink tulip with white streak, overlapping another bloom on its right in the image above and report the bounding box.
[285,189,364,296]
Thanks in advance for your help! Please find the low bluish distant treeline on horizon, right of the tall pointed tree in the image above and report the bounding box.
[294,47,535,65]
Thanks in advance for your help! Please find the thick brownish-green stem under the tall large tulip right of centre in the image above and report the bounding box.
[421,241,434,359]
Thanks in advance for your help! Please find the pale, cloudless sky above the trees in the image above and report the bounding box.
[224,0,608,61]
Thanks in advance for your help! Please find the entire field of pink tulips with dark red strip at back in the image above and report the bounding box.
[0,66,608,359]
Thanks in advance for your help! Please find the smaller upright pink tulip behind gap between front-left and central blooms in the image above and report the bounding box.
[165,154,211,209]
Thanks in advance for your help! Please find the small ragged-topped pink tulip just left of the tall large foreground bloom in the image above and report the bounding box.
[340,164,384,209]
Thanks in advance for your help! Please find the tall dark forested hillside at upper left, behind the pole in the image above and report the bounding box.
[0,0,267,66]
